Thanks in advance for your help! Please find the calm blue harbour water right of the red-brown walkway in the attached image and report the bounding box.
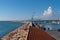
[39,22,60,30]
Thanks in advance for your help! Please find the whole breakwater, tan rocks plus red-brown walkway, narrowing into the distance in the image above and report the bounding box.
[1,22,55,40]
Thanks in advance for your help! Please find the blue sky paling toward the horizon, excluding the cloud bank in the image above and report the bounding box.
[0,0,60,20]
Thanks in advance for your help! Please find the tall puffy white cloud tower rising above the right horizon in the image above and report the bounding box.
[39,6,54,20]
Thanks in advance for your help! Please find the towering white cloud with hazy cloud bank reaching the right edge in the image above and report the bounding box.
[35,6,60,20]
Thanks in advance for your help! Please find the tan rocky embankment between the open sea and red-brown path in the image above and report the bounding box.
[1,23,29,40]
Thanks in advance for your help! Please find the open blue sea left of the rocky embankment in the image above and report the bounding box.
[0,21,23,38]
